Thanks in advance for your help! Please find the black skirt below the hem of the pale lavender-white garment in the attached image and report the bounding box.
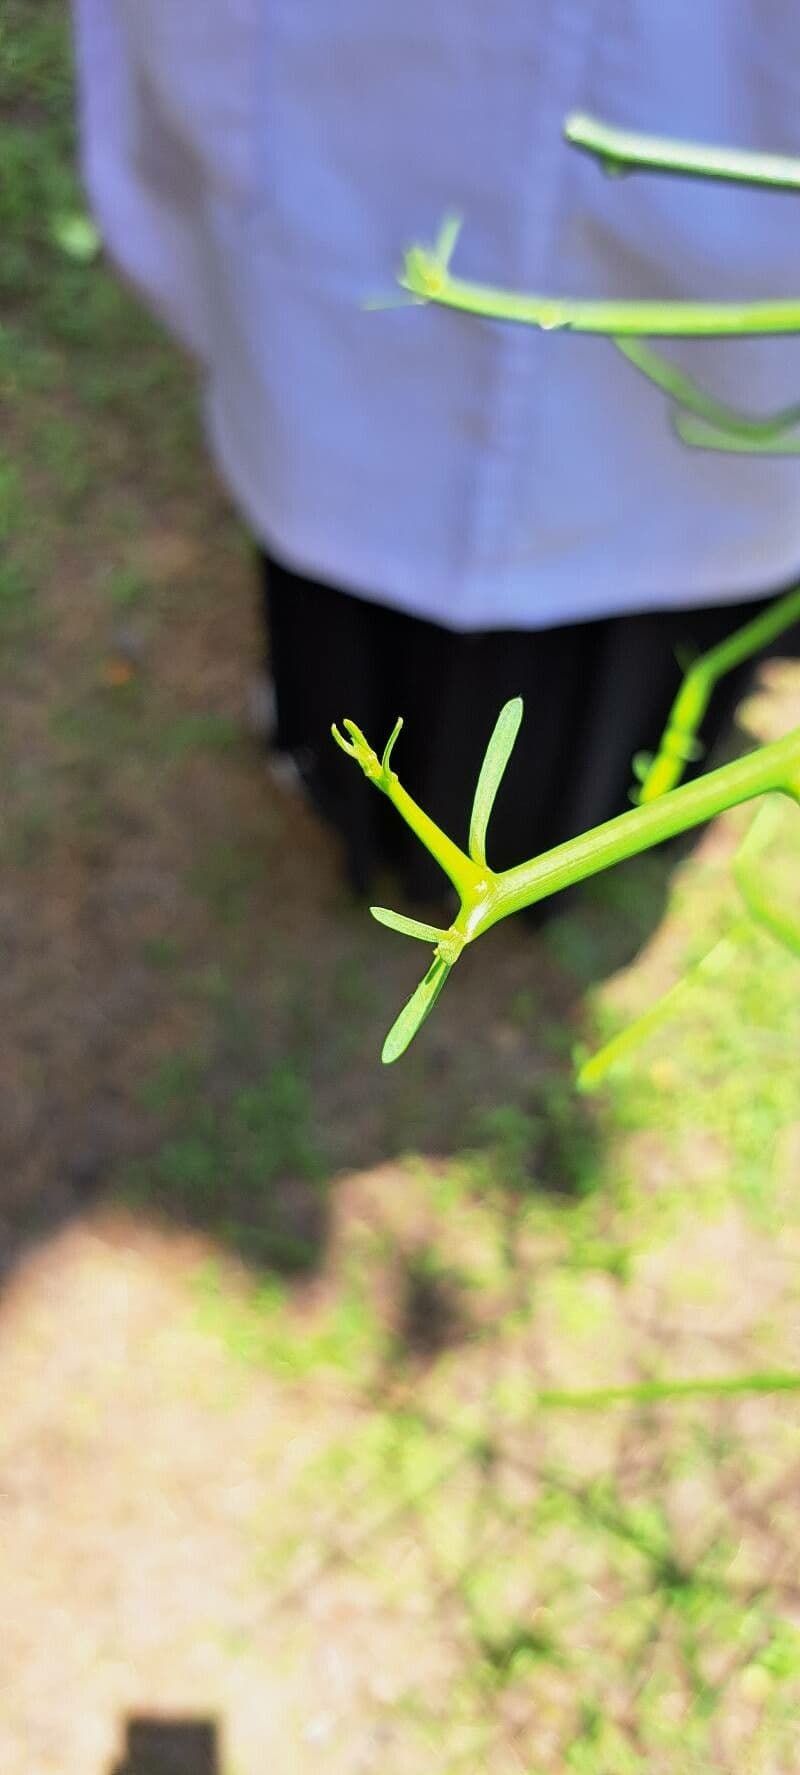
[261,556,787,903]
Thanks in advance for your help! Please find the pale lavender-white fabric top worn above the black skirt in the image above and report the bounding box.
[75,0,800,630]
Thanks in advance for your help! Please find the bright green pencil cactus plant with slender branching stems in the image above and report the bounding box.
[340,115,800,1088]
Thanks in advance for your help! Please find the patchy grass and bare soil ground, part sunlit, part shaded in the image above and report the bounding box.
[0,0,800,1775]
